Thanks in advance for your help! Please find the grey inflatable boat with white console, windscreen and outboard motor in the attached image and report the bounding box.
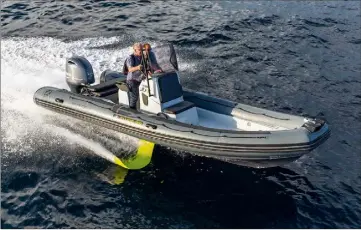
[34,44,330,168]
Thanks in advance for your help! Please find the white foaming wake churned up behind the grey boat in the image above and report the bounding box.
[1,37,194,164]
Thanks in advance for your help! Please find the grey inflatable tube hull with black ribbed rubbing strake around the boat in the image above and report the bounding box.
[34,87,330,167]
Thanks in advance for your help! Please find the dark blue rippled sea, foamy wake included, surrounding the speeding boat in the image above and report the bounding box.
[1,0,361,228]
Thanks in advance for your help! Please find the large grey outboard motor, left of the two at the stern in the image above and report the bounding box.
[65,56,95,93]
